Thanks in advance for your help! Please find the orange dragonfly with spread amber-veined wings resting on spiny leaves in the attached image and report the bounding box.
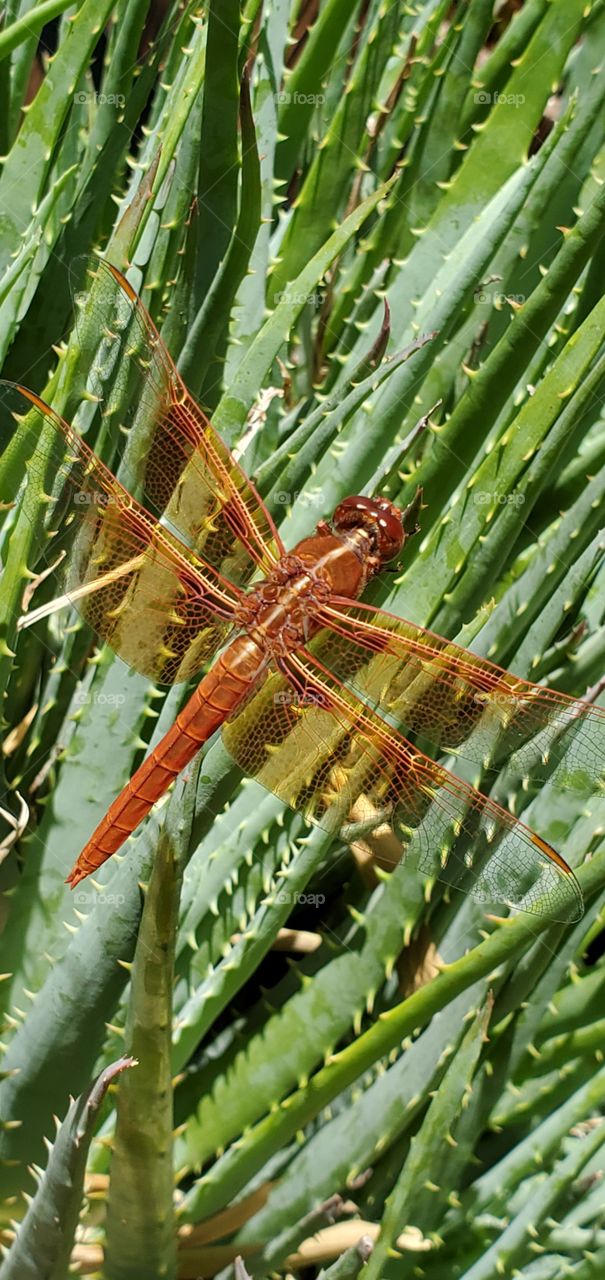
[4,261,605,920]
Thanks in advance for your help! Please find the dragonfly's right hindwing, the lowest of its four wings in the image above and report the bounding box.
[223,652,583,920]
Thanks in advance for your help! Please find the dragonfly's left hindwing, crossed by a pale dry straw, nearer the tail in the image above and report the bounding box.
[0,383,240,684]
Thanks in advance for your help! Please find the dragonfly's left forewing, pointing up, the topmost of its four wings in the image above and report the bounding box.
[77,259,283,585]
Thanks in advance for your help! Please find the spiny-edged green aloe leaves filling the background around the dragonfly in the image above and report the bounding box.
[0,0,605,1280]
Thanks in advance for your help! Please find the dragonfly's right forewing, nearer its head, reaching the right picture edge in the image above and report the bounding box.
[315,600,605,791]
